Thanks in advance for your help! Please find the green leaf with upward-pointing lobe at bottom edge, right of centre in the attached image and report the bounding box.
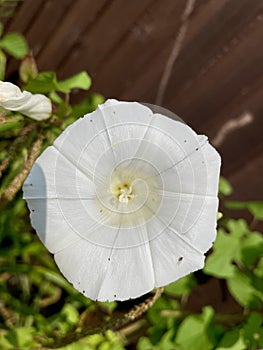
[175,306,217,350]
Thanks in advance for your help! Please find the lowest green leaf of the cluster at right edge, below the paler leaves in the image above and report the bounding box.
[227,270,263,308]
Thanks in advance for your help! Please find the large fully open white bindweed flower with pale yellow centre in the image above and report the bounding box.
[23,100,220,301]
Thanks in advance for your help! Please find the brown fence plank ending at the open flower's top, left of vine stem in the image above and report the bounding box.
[93,0,185,96]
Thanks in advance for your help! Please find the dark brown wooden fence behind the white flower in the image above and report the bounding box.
[1,0,263,200]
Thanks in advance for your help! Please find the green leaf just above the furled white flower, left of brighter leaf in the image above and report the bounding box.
[24,71,58,94]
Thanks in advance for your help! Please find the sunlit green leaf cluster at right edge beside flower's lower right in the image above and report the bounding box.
[204,219,263,308]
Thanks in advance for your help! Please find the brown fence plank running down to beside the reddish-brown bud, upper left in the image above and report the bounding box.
[38,0,107,70]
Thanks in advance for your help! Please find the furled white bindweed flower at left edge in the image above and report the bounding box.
[0,81,52,121]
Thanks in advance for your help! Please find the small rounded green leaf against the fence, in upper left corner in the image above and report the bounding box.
[0,33,29,59]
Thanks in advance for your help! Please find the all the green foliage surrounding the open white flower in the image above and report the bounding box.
[0,21,263,350]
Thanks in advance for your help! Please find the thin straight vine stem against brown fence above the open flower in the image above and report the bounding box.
[155,0,196,105]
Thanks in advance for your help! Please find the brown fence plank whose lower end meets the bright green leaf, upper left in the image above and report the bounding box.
[60,0,153,76]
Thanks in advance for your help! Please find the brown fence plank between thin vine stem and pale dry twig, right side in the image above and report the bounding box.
[168,9,263,126]
